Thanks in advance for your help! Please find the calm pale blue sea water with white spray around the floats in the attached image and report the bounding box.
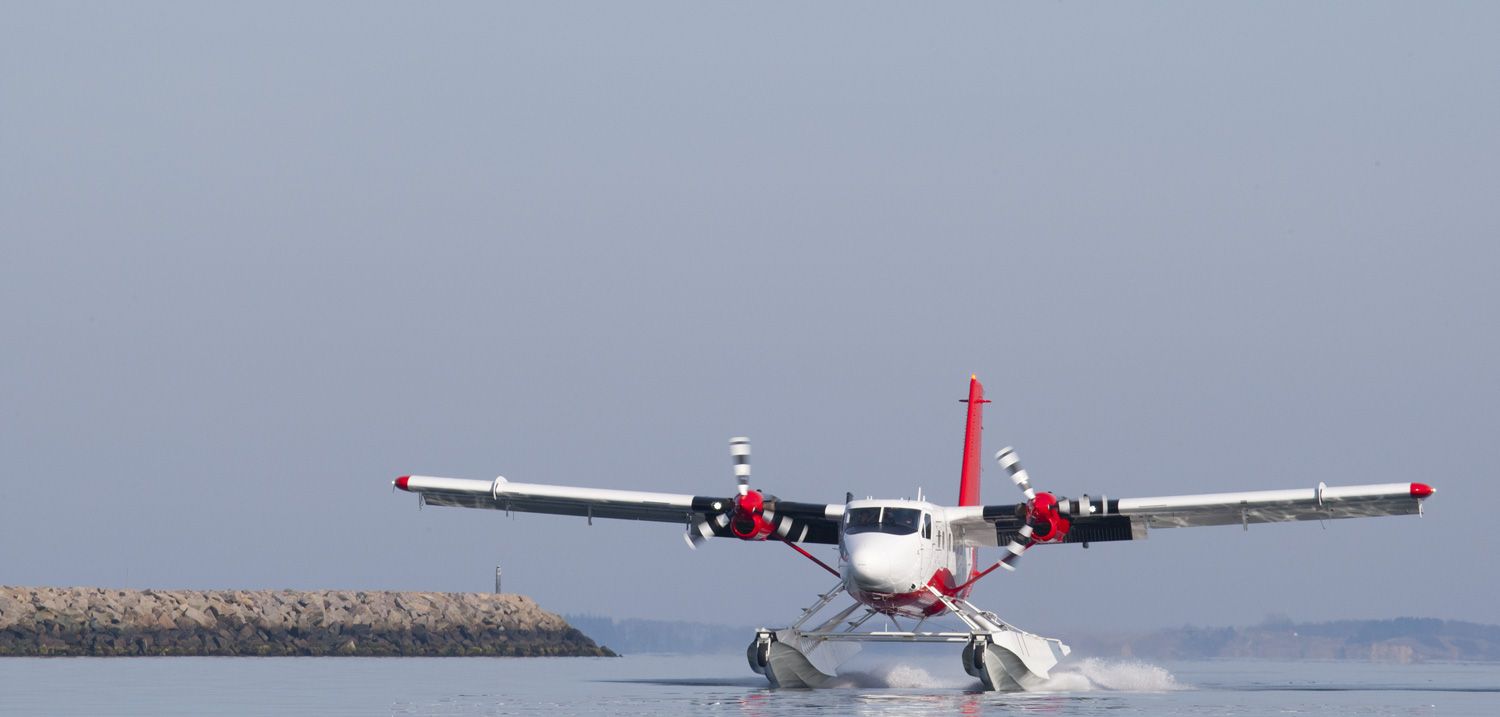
[0,654,1500,717]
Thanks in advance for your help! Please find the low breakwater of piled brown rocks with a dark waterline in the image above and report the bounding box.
[0,587,614,657]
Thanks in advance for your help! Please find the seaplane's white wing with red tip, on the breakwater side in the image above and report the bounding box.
[396,476,843,545]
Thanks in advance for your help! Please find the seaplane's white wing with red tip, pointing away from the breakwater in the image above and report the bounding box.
[948,483,1436,546]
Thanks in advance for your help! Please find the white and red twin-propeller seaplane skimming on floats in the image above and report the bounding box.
[393,377,1434,692]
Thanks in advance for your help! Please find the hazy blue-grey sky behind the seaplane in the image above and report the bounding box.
[0,2,1500,635]
